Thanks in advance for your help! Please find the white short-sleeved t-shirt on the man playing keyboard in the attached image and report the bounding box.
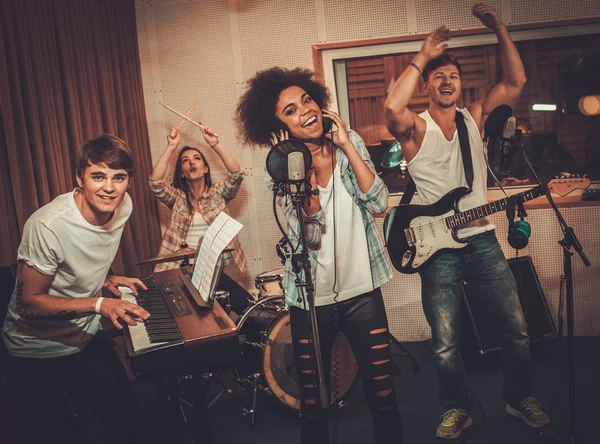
[2,191,133,358]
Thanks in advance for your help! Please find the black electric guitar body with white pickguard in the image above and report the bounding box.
[384,187,471,274]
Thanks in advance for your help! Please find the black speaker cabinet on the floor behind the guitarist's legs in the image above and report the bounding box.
[461,256,556,356]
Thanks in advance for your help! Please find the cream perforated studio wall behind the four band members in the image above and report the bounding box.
[136,0,600,341]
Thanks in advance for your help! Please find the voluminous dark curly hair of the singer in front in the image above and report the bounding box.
[236,66,330,146]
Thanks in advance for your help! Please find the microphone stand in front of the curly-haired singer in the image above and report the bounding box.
[289,181,330,409]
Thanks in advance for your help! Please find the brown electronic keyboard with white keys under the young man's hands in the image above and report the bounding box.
[123,269,242,378]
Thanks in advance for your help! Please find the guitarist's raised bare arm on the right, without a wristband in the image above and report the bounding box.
[469,3,527,125]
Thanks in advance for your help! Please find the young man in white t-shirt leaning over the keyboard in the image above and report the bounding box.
[2,134,150,444]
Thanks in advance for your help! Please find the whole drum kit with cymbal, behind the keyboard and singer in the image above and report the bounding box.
[138,247,358,426]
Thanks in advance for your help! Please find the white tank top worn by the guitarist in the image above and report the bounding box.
[408,108,494,238]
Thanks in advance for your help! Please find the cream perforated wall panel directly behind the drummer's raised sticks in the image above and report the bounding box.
[154,0,243,163]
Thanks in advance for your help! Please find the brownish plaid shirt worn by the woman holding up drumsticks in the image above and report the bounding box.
[149,171,246,273]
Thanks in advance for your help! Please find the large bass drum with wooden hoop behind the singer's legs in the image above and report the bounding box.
[235,296,358,412]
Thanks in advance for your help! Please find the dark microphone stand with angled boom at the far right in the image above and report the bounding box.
[516,143,591,444]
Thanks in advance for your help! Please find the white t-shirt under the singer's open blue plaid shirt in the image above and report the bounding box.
[315,165,373,306]
